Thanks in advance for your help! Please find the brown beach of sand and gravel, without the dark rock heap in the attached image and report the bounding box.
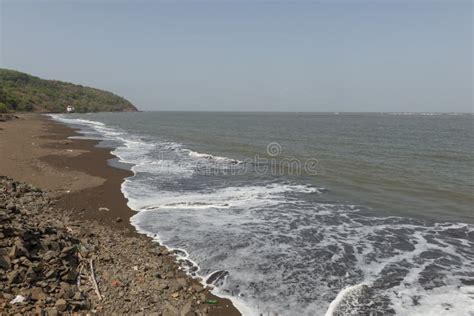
[0,114,240,316]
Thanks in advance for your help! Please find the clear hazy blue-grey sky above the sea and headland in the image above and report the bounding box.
[0,0,474,112]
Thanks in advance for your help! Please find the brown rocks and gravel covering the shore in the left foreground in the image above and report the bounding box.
[0,176,237,316]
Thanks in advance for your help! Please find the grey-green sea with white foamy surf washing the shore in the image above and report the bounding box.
[53,112,474,315]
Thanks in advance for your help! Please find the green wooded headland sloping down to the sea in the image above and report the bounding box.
[0,68,137,112]
